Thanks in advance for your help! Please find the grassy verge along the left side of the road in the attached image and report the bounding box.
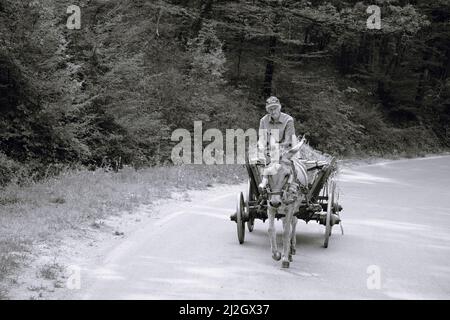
[0,165,247,299]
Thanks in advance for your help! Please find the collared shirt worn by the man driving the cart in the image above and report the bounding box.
[258,112,295,149]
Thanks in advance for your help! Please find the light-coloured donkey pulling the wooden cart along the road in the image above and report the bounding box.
[259,140,308,268]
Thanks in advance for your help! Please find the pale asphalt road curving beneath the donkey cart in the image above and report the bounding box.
[73,156,450,299]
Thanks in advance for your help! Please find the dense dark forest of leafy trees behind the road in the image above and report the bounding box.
[0,0,450,185]
